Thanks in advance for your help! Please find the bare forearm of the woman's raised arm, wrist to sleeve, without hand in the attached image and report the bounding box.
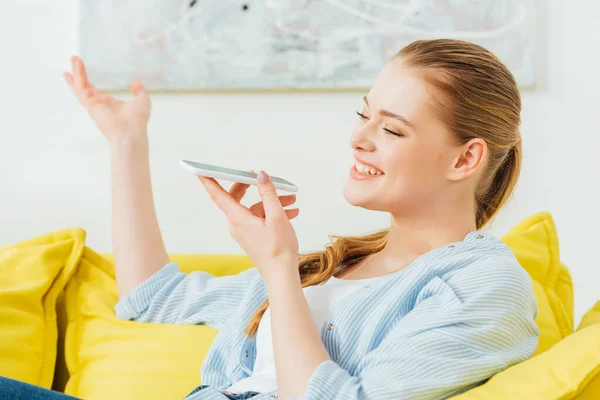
[110,135,169,298]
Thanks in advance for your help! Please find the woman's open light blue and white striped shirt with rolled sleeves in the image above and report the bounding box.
[115,231,539,400]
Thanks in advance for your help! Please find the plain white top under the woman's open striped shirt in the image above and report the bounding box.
[226,277,378,393]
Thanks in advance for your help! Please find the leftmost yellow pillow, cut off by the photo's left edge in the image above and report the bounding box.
[0,228,85,389]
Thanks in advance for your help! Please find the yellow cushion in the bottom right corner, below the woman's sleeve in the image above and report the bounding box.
[452,324,600,400]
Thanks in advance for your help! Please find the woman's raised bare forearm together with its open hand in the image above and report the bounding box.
[64,57,169,297]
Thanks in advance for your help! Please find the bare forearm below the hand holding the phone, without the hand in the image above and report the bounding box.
[267,268,331,400]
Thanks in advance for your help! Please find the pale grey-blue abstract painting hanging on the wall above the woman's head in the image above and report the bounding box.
[79,0,535,90]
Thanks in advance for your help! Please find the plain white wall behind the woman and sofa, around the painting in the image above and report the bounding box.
[0,0,600,319]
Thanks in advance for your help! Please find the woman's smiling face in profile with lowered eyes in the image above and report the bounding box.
[344,61,460,214]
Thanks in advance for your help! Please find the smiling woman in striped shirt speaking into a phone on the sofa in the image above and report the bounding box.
[0,40,539,400]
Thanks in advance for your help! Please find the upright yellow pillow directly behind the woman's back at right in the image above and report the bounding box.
[502,212,573,354]
